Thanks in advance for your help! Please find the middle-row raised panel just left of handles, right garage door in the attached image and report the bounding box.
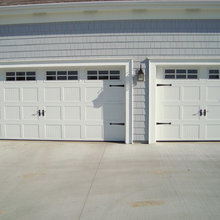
[182,105,200,120]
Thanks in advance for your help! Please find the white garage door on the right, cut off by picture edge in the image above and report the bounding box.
[156,67,220,141]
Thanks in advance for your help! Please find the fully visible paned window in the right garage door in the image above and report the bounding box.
[164,69,198,79]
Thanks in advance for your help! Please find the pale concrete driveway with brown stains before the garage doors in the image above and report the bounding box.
[0,141,220,220]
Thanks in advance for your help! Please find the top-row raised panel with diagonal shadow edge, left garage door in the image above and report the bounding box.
[85,87,103,104]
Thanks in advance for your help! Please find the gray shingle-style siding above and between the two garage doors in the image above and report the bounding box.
[0,20,220,141]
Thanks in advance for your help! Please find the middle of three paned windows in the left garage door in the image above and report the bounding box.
[46,71,78,80]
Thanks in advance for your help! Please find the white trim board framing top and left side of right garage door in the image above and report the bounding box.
[148,57,220,144]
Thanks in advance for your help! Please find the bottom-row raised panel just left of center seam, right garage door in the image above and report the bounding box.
[182,125,200,140]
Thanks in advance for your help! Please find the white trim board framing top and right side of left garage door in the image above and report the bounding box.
[0,59,133,144]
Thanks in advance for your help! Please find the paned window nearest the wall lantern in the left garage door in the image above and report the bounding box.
[87,70,120,80]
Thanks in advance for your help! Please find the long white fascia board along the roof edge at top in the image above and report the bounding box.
[0,1,220,15]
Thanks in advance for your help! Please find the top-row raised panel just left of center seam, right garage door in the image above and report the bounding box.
[183,86,200,101]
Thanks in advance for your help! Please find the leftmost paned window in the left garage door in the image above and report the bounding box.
[6,72,36,81]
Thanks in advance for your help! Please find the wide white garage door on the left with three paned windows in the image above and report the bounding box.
[0,67,125,141]
